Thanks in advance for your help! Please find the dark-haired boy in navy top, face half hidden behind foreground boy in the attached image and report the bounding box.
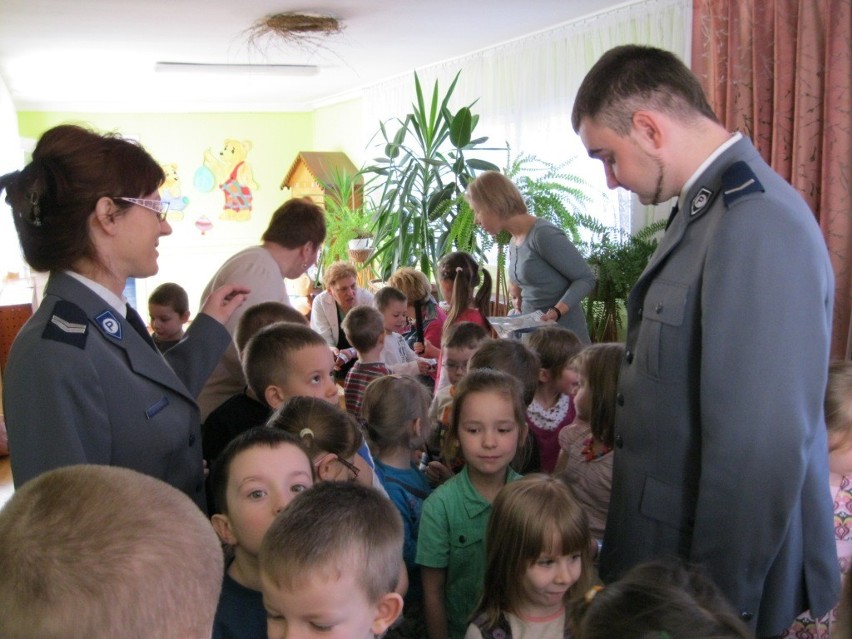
[210,426,314,639]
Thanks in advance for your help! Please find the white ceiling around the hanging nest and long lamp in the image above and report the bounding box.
[0,0,624,112]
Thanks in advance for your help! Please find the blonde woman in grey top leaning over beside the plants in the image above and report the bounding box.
[467,171,595,344]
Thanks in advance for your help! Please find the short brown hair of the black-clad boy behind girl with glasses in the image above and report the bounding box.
[243,322,328,403]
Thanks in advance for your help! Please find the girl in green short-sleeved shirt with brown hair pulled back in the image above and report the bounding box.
[416,370,527,639]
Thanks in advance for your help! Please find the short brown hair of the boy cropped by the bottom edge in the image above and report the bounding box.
[260,482,403,604]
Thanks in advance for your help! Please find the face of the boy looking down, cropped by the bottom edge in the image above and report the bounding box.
[260,562,401,639]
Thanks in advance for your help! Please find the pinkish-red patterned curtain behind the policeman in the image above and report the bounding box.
[692,0,852,358]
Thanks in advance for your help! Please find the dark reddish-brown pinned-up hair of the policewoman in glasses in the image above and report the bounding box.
[0,124,165,271]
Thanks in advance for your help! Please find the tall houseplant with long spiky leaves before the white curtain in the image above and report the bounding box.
[364,73,498,277]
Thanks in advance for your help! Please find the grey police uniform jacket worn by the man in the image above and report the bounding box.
[601,139,839,636]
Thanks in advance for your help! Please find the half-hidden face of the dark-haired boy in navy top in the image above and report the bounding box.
[213,443,313,557]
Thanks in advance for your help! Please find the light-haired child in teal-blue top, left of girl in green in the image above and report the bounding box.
[362,375,432,637]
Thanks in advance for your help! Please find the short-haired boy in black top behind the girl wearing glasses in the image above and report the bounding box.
[202,322,338,462]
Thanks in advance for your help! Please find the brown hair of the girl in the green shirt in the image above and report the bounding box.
[441,368,527,460]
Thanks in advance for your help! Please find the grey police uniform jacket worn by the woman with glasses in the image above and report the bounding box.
[3,273,230,509]
